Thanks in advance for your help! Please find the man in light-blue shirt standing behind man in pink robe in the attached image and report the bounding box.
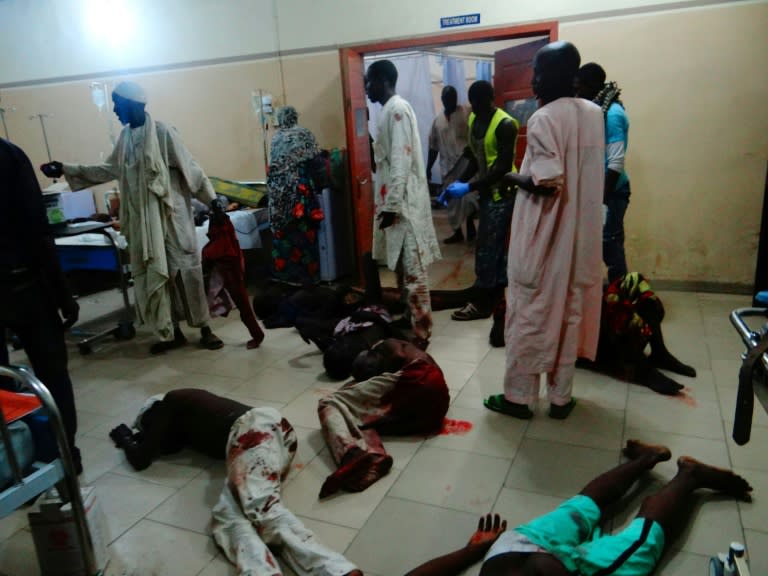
[574,62,630,283]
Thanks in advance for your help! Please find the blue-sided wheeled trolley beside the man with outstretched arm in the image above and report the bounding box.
[54,222,136,355]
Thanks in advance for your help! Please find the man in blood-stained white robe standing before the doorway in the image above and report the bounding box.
[365,60,440,349]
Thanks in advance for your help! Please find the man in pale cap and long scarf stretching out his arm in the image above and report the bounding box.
[45,82,223,354]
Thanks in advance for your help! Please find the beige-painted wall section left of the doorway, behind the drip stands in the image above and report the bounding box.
[2,51,344,186]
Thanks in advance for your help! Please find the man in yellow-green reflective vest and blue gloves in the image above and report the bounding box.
[446,80,519,320]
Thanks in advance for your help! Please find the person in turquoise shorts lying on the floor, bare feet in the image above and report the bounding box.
[406,440,752,576]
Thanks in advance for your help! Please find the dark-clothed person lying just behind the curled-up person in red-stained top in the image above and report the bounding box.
[296,305,405,380]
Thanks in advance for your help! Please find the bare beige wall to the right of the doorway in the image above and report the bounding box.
[560,3,768,285]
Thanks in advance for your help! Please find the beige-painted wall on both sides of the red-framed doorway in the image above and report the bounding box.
[2,2,768,285]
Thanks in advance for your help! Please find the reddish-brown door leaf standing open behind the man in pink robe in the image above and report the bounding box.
[493,38,551,170]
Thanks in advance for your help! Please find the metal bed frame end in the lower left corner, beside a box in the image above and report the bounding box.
[0,366,98,575]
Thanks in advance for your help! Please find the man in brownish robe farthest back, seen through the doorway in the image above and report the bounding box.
[427,86,478,244]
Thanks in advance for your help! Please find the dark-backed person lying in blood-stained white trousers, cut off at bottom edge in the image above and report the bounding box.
[110,388,362,576]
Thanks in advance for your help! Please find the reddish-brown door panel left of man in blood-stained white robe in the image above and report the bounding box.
[340,49,374,275]
